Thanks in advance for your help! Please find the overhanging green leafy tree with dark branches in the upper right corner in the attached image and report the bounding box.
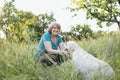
[70,0,120,29]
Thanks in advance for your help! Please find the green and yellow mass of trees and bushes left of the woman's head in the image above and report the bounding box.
[0,0,55,42]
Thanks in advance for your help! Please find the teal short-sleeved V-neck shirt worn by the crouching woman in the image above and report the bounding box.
[35,32,62,57]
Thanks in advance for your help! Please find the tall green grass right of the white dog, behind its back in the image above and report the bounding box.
[78,32,120,80]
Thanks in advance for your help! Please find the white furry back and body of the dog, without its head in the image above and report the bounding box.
[72,50,115,80]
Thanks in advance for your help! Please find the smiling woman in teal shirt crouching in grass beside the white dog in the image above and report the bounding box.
[35,23,69,66]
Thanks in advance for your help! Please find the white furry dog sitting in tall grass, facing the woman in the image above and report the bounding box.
[66,41,115,80]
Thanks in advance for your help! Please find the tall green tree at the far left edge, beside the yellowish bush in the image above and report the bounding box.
[0,0,17,40]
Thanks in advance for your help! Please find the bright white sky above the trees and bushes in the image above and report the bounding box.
[0,0,118,32]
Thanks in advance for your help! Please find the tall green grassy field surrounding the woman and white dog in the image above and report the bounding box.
[0,33,120,80]
